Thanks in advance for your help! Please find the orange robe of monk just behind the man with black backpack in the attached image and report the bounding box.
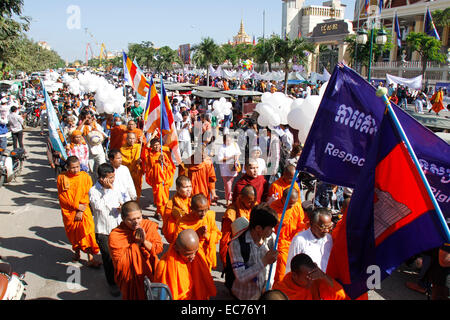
[219,198,256,266]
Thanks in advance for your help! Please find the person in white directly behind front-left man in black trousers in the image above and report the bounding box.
[108,149,137,202]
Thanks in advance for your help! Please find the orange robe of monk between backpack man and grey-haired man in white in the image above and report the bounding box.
[270,199,309,282]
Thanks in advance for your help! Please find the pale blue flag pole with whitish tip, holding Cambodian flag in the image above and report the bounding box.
[377,88,450,242]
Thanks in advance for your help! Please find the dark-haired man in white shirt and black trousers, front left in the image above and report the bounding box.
[89,163,125,296]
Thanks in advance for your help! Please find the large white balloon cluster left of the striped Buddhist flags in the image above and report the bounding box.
[78,71,126,114]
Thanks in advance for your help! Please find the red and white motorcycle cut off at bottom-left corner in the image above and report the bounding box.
[0,263,26,300]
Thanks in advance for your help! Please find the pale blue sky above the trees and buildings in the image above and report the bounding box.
[24,0,355,62]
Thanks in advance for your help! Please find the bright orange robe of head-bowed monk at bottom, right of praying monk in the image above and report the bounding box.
[154,243,217,300]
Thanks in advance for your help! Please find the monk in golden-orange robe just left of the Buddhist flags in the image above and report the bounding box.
[120,132,144,199]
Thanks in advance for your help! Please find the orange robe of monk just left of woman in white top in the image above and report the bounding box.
[178,158,217,203]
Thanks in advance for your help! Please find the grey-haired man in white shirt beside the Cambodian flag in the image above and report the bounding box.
[286,208,333,274]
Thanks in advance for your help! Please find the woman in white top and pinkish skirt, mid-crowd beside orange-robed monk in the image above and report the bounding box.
[217,135,241,206]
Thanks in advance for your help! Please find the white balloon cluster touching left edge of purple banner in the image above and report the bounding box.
[255,83,327,144]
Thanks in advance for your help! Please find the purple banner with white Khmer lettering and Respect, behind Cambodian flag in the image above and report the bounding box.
[298,65,450,217]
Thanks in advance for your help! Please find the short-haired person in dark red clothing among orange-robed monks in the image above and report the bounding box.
[233,158,269,203]
